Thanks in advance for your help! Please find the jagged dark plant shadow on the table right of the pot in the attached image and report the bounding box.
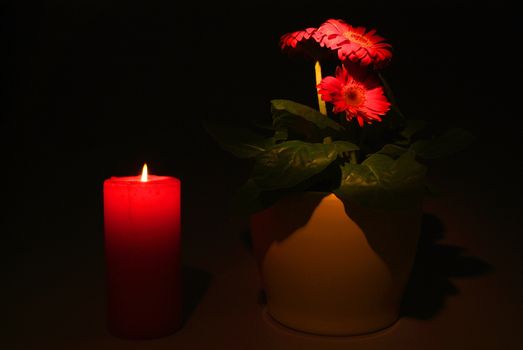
[400,213,492,319]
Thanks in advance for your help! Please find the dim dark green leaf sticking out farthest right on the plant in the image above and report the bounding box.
[410,128,474,159]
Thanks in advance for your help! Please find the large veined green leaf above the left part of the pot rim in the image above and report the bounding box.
[252,140,338,190]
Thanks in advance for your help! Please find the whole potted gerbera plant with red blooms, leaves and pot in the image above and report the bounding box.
[206,19,472,335]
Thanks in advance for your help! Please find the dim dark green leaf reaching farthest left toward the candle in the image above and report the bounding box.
[204,121,275,158]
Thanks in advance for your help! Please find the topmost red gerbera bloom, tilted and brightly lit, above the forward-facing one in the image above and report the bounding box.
[314,19,392,66]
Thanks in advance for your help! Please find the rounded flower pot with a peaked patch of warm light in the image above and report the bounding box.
[250,192,422,335]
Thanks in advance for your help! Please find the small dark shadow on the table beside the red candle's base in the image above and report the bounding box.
[182,265,212,324]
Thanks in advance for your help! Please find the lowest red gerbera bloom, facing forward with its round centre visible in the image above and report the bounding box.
[318,65,390,126]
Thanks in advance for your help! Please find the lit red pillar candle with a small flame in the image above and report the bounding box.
[104,165,182,339]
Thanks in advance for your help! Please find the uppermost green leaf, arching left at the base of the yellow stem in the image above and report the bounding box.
[271,99,343,131]
